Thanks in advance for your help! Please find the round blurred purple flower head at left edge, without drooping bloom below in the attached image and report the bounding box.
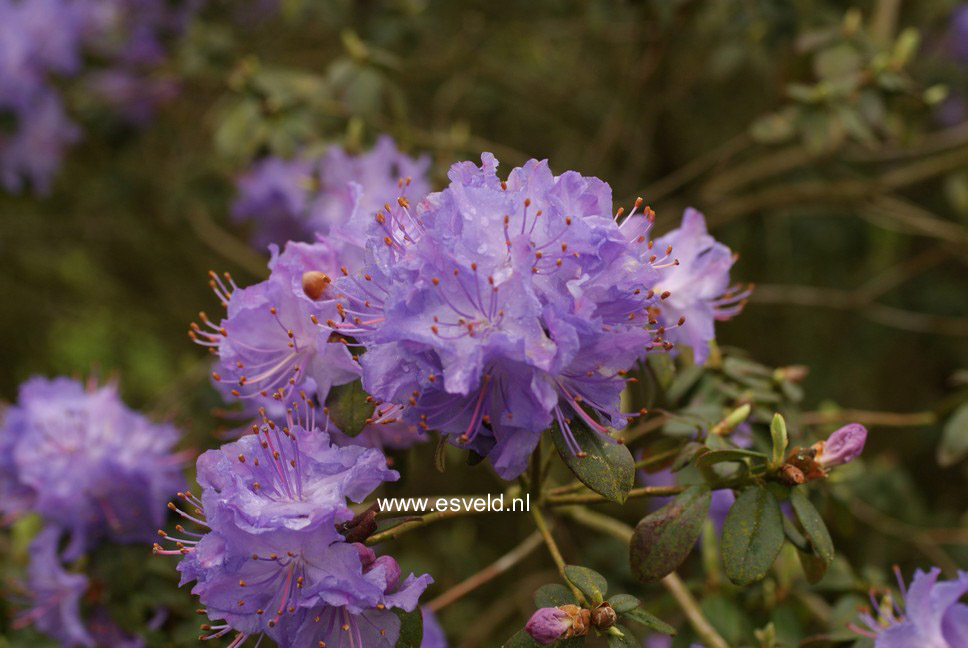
[0,378,184,559]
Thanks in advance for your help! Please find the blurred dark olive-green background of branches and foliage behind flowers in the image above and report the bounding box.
[0,0,968,646]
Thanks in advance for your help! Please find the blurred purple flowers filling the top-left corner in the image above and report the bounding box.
[0,0,198,194]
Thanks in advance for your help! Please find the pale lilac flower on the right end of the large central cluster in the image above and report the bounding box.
[655,208,749,364]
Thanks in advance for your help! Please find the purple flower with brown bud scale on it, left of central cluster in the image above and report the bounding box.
[195,242,360,406]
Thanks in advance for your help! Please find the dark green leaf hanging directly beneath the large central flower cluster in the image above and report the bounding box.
[551,417,635,504]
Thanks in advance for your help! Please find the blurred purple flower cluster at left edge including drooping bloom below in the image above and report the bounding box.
[0,378,186,647]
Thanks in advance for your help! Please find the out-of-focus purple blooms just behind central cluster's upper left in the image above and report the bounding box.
[232,135,430,254]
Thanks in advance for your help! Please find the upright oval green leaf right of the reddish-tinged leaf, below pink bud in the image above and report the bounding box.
[722,486,783,585]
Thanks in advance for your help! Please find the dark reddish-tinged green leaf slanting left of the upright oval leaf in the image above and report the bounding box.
[629,485,712,583]
